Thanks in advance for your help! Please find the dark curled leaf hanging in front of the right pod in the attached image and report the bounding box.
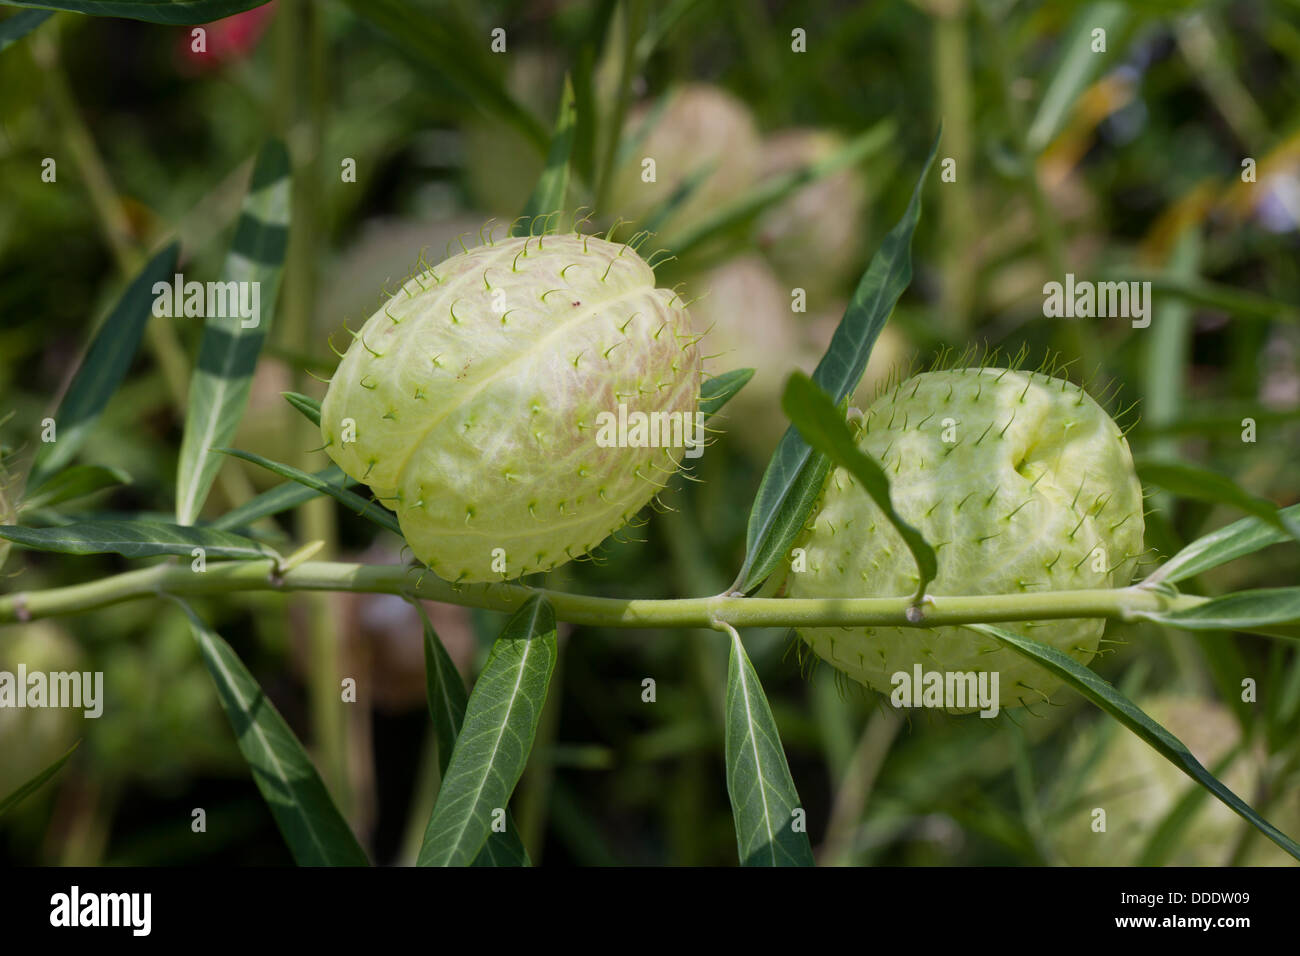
[781,372,939,601]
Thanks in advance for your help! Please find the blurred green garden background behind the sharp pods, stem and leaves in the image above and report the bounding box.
[0,0,1300,865]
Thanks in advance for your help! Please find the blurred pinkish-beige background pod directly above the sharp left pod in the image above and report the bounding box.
[598,83,761,238]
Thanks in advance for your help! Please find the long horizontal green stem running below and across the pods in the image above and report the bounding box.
[0,561,1206,627]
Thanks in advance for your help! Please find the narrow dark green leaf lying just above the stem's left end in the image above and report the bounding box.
[0,520,280,561]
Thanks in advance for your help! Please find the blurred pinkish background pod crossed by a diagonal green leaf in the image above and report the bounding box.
[755,129,867,308]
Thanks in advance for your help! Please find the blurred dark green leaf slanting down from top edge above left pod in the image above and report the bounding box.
[346,0,550,153]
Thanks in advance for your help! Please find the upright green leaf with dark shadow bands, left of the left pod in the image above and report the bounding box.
[176,139,290,524]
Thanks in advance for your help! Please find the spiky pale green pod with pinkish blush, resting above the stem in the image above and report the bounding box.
[321,234,701,581]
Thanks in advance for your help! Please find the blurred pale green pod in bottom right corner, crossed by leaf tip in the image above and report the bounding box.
[1056,695,1300,866]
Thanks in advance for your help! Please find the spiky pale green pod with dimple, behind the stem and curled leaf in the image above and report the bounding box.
[787,368,1143,713]
